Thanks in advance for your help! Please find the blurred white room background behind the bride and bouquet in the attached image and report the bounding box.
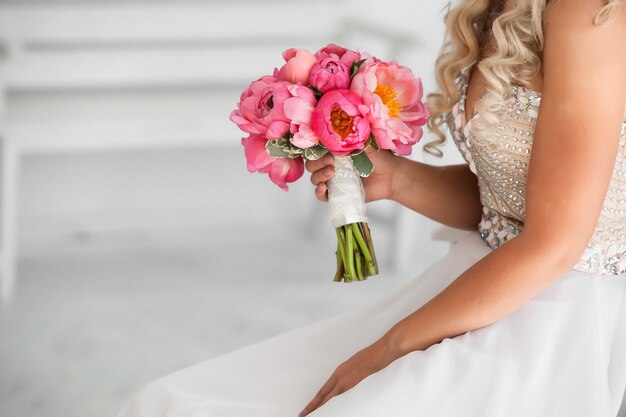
[0,0,464,417]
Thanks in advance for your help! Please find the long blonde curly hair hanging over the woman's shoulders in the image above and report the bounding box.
[424,0,622,157]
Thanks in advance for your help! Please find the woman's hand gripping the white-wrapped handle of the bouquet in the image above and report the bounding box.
[306,146,405,202]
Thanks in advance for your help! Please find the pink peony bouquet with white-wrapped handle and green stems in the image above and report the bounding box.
[230,44,430,282]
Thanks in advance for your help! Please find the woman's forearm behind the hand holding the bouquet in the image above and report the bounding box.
[391,158,482,230]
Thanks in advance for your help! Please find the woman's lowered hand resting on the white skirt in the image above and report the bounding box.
[298,336,401,417]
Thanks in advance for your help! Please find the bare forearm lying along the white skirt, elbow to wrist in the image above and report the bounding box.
[383,233,573,357]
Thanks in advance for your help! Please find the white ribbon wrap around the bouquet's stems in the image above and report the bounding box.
[327,156,367,228]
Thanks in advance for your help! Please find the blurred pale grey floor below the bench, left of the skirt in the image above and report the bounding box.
[0,234,425,417]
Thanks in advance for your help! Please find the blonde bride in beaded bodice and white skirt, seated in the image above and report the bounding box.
[120,0,626,417]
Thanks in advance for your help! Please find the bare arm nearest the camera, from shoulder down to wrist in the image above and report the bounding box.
[385,0,626,354]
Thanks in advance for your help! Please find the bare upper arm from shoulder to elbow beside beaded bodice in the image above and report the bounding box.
[524,0,626,250]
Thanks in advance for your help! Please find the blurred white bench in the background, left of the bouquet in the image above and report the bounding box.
[0,0,424,304]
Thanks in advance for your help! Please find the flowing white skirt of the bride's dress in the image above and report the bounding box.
[119,231,626,417]
